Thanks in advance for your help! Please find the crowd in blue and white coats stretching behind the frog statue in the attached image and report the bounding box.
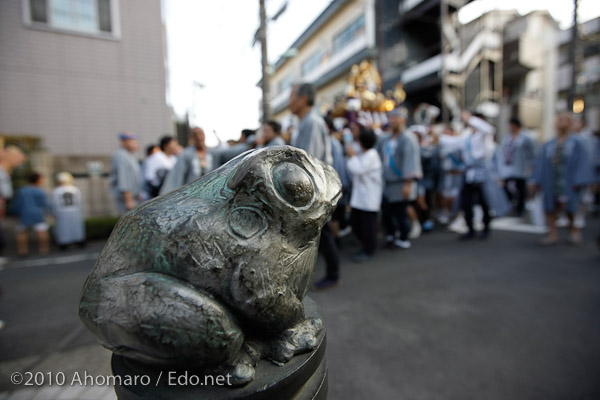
[111,83,600,288]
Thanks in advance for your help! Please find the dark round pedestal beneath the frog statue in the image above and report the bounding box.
[112,297,327,400]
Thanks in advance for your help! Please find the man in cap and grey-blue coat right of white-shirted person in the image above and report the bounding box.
[378,108,423,249]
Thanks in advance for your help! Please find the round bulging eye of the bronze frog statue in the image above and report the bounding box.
[273,162,315,207]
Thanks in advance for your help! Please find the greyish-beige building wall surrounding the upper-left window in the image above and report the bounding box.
[0,0,172,157]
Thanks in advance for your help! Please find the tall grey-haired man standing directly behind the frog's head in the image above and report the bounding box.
[289,83,340,289]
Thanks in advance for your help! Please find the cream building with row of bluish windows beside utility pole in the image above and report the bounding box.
[271,0,377,128]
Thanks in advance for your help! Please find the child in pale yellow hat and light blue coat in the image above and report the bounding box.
[51,172,85,250]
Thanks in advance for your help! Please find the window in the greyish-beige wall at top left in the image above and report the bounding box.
[25,0,115,34]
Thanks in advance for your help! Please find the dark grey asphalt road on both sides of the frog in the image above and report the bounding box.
[0,221,600,400]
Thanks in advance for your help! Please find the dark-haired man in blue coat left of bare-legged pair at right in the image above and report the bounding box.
[494,118,535,217]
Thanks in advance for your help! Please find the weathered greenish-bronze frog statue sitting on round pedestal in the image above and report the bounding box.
[79,146,341,385]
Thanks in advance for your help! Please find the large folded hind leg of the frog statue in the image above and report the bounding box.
[80,272,254,383]
